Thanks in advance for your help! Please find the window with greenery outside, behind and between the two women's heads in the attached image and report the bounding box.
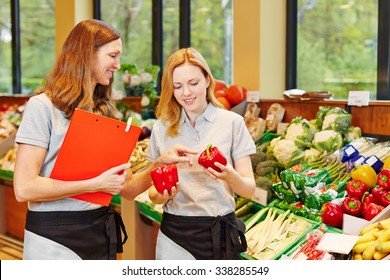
[100,0,233,93]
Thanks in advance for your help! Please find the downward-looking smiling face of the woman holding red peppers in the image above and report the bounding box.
[172,63,210,117]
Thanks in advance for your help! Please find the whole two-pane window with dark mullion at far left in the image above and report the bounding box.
[0,0,55,94]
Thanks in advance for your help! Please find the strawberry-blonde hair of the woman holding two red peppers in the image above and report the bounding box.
[156,48,223,137]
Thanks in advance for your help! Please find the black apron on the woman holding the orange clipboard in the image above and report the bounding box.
[26,207,127,260]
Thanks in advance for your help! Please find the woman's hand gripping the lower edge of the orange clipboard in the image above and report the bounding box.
[95,163,131,195]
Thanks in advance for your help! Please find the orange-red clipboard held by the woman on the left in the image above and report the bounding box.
[50,109,141,206]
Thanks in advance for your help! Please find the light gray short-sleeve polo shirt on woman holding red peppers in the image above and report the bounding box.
[147,104,256,216]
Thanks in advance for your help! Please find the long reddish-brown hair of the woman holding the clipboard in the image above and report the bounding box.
[35,19,121,119]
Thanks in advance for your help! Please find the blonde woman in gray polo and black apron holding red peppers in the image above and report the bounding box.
[147,48,256,259]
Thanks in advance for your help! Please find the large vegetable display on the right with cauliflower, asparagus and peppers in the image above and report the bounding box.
[130,104,390,260]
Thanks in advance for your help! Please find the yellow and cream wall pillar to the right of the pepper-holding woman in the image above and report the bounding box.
[233,0,286,98]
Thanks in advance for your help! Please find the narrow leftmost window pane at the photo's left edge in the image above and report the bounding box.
[0,0,12,94]
